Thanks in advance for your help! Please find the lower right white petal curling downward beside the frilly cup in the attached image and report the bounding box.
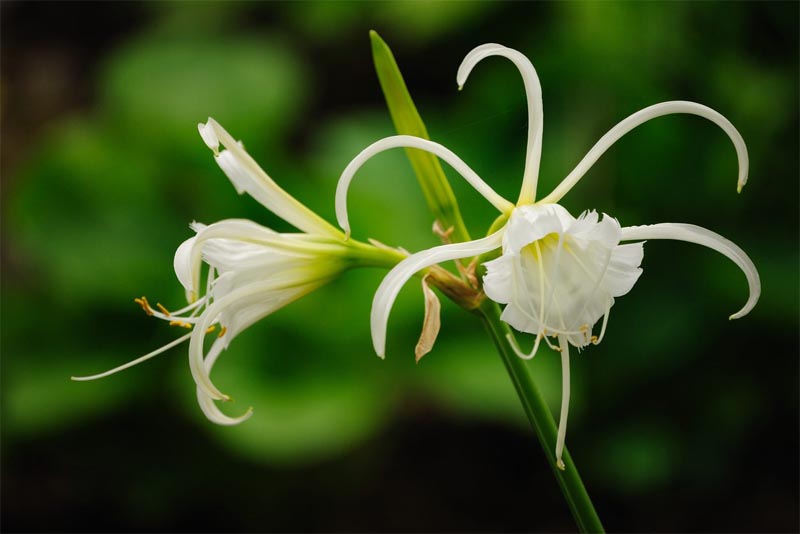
[622,223,761,319]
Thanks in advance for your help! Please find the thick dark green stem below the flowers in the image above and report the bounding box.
[476,299,604,532]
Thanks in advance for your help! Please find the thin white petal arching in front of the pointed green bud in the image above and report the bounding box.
[336,135,514,235]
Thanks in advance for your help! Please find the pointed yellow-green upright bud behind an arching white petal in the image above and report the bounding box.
[369,31,470,241]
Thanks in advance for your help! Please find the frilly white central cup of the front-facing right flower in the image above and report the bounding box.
[484,204,643,347]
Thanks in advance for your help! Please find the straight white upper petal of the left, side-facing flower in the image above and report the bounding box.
[197,121,342,239]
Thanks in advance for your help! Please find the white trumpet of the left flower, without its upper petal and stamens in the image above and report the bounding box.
[175,220,349,410]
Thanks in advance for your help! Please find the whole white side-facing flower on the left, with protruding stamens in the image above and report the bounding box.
[73,118,360,425]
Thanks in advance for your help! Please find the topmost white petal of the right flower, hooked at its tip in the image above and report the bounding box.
[456,43,544,205]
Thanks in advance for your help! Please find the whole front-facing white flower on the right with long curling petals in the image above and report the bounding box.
[336,44,761,468]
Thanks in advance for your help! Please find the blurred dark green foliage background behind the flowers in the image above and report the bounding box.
[0,2,800,532]
